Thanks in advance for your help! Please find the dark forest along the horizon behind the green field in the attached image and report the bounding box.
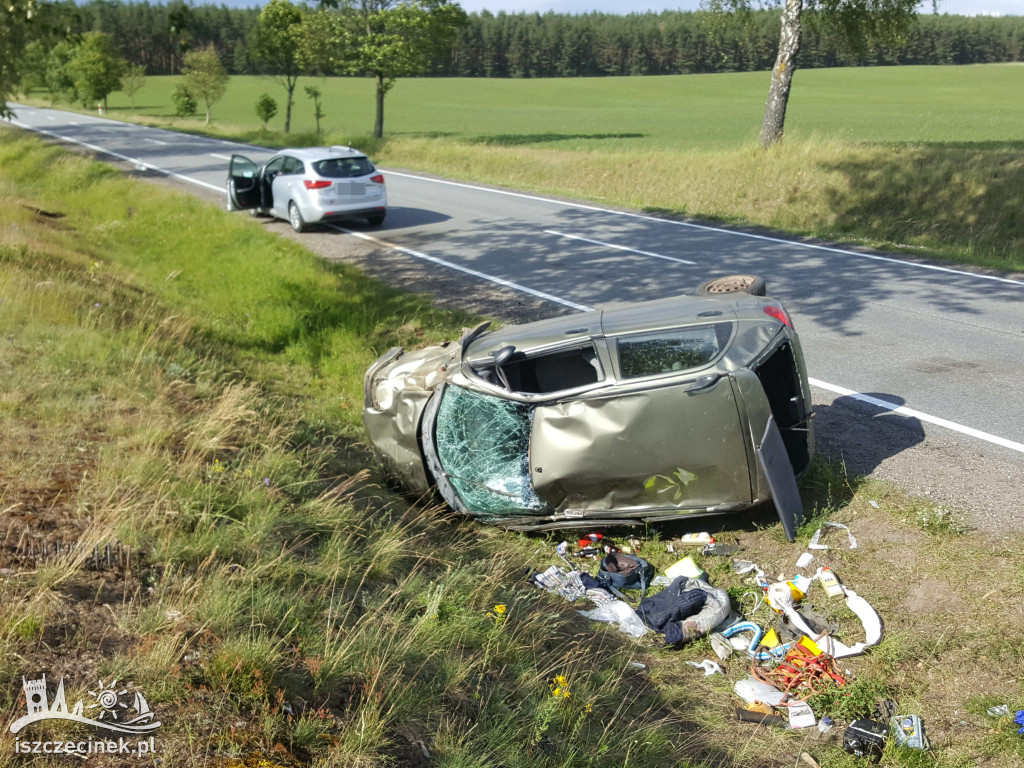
[28,0,1024,77]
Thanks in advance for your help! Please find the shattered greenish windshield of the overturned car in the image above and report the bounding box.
[435,386,547,515]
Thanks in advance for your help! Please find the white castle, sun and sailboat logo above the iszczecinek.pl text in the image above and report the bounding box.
[10,675,160,733]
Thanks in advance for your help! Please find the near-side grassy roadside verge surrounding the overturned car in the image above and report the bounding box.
[0,131,1024,768]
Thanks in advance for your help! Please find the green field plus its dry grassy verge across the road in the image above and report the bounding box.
[16,63,1024,270]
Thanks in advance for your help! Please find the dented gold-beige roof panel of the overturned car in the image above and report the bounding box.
[530,377,751,514]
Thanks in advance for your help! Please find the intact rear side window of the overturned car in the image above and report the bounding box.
[615,323,732,379]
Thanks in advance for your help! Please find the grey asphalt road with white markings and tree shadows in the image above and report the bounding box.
[12,106,1024,531]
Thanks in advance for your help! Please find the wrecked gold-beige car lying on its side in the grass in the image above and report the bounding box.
[362,275,813,538]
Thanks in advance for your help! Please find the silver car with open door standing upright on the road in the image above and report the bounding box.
[227,146,387,232]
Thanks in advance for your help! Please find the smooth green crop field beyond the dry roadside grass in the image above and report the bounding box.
[86,65,1024,151]
